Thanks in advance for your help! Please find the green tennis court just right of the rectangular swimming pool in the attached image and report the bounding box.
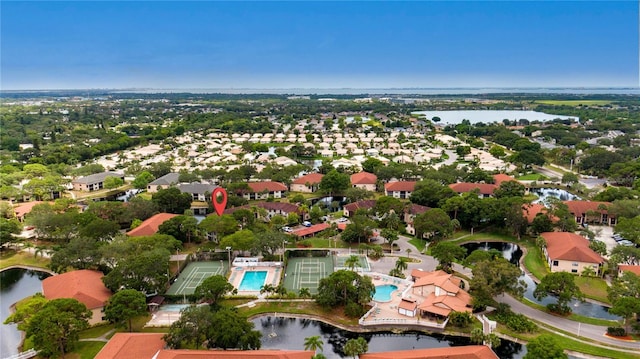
[284,257,333,294]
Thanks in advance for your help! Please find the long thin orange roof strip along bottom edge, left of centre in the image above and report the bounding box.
[154,349,315,359]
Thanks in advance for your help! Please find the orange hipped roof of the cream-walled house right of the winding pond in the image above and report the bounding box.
[540,232,604,263]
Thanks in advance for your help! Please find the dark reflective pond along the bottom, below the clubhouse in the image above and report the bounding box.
[252,316,526,359]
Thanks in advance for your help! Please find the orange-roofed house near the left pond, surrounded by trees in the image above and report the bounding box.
[42,269,111,325]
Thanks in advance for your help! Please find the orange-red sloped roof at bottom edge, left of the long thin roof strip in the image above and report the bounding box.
[94,333,165,359]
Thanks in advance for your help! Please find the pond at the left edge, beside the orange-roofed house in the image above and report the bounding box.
[0,268,50,358]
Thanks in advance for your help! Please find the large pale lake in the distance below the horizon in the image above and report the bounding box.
[412,110,578,125]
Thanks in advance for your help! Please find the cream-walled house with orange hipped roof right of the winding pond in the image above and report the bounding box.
[540,232,604,273]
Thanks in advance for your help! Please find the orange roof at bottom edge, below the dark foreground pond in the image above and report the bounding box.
[359,345,499,359]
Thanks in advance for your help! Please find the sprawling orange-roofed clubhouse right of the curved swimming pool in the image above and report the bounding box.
[411,270,471,319]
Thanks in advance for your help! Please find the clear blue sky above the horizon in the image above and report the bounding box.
[0,0,639,90]
